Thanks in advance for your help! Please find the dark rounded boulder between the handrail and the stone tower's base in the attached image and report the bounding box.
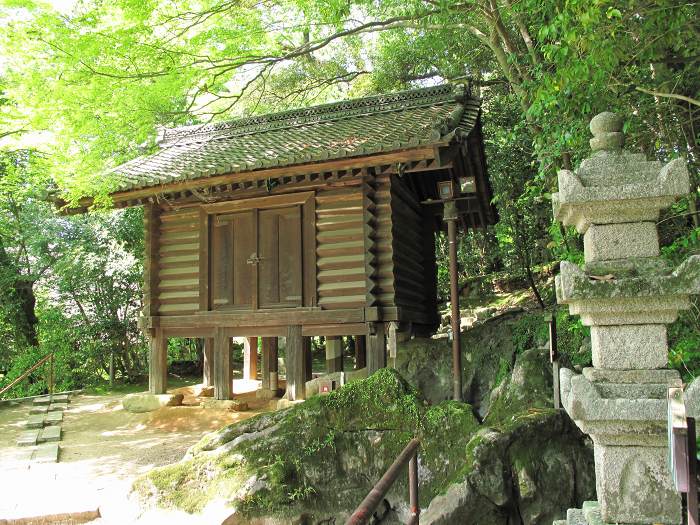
[421,409,595,525]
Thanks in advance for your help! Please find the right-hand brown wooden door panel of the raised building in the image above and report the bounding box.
[258,206,302,308]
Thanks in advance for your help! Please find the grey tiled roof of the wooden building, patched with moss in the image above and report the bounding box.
[109,84,479,191]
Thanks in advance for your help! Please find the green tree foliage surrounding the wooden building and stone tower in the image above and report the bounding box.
[0,0,700,388]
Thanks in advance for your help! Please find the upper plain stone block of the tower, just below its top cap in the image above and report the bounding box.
[583,222,659,263]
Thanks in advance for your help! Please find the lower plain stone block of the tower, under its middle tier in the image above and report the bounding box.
[591,324,668,370]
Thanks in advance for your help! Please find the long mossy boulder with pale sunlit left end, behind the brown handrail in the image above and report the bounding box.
[135,369,479,522]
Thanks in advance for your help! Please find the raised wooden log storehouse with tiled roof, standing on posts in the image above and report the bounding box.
[95,85,496,399]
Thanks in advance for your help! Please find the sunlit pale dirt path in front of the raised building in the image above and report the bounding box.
[0,381,268,524]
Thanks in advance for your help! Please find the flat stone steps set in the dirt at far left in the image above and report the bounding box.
[17,394,70,463]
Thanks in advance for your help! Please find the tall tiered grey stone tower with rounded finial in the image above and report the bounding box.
[552,113,700,524]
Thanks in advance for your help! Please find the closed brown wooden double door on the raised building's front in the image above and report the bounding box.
[210,204,303,310]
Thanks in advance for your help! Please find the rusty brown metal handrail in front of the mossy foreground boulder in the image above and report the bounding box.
[345,439,420,525]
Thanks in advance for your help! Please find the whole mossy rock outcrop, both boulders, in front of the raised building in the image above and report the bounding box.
[135,363,593,525]
